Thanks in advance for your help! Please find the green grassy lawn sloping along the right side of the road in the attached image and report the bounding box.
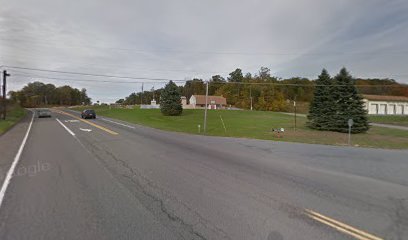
[71,107,408,149]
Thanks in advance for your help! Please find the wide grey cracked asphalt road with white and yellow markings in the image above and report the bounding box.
[0,110,408,240]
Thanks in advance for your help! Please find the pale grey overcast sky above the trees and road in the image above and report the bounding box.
[0,0,408,102]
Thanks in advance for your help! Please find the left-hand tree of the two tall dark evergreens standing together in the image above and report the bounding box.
[307,69,336,130]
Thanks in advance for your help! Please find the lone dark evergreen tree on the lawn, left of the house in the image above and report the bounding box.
[160,81,183,116]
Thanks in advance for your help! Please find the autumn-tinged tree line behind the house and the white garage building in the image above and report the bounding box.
[117,67,408,111]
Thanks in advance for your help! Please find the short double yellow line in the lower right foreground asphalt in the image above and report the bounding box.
[305,209,383,240]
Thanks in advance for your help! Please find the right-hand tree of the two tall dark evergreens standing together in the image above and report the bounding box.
[332,68,369,133]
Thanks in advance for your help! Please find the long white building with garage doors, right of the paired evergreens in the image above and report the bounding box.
[363,95,408,115]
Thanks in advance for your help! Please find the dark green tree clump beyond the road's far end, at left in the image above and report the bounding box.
[8,82,91,107]
